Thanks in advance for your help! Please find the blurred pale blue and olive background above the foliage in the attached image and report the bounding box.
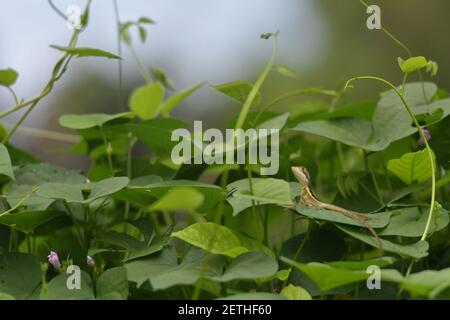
[0,0,450,166]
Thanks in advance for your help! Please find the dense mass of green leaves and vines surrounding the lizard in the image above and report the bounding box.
[0,0,450,300]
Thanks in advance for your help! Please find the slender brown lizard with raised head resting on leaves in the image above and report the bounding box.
[291,167,383,255]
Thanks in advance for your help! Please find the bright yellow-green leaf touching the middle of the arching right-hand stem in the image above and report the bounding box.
[388,149,435,184]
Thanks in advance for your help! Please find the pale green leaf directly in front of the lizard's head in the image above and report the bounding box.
[227,178,293,215]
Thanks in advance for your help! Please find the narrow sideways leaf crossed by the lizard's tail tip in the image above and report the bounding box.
[337,225,429,259]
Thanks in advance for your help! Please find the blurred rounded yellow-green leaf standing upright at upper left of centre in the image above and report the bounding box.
[129,82,164,120]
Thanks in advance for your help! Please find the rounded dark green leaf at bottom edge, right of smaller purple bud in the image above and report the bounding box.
[96,267,128,300]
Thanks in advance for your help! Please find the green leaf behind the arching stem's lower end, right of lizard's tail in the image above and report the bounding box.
[379,207,449,238]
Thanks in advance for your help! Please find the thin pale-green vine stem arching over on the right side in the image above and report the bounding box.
[345,76,436,241]
